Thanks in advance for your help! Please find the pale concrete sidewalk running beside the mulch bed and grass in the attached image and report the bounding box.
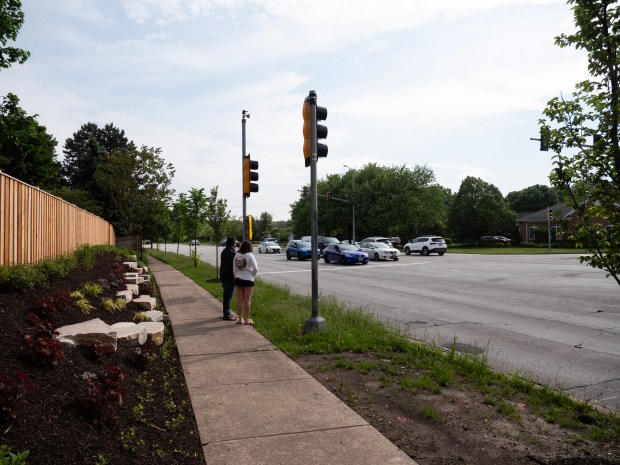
[149,257,416,465]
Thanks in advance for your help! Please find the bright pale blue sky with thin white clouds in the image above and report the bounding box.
[0,0,588,221]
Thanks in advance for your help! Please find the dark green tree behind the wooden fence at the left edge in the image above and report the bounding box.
[0,93,61,189]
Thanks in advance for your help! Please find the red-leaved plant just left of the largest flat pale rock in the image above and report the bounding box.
[23,315,65,367]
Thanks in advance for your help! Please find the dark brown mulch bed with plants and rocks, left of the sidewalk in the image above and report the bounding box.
[0,253,205,465]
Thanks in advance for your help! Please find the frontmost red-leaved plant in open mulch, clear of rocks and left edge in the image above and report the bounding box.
[77,365,127,424]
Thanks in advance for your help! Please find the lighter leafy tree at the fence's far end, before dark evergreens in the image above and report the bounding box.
[94,146,174,236]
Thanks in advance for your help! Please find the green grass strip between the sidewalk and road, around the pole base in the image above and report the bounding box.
[148,250,620,441]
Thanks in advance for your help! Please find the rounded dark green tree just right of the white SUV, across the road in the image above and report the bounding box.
[448,176,517,242]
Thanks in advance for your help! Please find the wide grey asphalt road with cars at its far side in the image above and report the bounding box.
[161,245,620,411]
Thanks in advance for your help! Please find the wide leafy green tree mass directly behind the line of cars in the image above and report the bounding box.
[291,163,448,239]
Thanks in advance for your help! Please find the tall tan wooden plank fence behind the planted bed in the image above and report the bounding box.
[0,172,115,265]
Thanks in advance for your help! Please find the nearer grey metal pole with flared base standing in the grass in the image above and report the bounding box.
[304,90,326,334]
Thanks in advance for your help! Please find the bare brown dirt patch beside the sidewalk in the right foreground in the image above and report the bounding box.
[295,353,620,465]
